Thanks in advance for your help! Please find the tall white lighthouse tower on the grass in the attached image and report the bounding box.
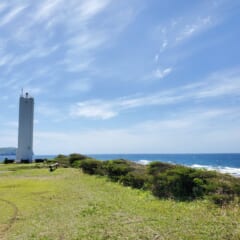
[16,93,34,162]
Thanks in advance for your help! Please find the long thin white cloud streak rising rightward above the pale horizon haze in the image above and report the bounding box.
[71,67,240,120]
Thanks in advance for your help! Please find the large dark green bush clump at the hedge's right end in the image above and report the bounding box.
[152,166,240,205]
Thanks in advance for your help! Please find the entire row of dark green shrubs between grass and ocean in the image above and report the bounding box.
[52,154,240,205]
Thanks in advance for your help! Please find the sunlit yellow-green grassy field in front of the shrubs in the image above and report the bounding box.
[0,164,240,240]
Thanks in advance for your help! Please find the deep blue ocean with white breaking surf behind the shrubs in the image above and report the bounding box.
[0,153,240,177]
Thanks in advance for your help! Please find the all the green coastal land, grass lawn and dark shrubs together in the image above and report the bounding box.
[0,154,240,240]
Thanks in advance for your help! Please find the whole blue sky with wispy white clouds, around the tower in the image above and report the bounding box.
[0,0,240,154]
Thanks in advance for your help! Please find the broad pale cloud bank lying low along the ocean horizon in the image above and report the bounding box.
[35,108,240,154]
